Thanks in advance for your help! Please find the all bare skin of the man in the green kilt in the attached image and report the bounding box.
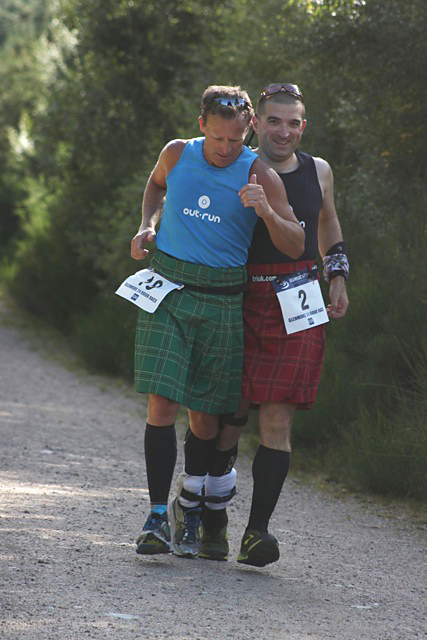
[131,114,304,440]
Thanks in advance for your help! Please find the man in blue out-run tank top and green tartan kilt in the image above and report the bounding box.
[131,86,304,557]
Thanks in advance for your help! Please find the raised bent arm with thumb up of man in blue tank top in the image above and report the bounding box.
[239,159,305,259]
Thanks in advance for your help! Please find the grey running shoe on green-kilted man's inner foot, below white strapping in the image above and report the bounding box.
[168,498,202,558]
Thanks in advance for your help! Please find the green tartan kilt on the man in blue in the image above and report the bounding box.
[135,251,246,414]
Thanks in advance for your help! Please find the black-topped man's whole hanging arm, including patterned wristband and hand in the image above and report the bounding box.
[314,158,348,319]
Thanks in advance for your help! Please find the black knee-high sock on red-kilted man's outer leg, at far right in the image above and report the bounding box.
[248,445,291,531]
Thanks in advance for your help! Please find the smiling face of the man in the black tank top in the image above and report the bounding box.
[253,100,307,162]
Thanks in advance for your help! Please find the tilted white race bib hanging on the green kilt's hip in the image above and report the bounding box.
[116,269,184,313]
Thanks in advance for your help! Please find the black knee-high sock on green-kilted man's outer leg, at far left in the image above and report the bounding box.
[144,422,177,504]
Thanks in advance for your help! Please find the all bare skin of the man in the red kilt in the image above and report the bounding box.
[219,100,348,452]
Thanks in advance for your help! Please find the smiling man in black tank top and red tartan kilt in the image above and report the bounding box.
[200,83,348,567]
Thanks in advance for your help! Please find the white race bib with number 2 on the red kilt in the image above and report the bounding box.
[273,271,329,334]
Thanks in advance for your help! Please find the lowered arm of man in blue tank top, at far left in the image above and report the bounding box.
[130,140,185,260]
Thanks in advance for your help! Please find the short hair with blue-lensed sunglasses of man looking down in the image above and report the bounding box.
[200,85,254,124]
